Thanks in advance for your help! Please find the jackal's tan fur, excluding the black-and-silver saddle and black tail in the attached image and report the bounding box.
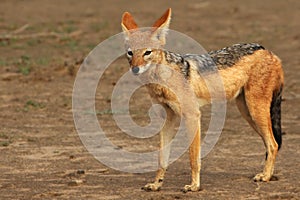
[122,9,283,192]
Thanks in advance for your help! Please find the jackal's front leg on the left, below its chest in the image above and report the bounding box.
[142,106,180,191]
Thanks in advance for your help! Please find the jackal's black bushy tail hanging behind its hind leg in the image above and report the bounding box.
[270,85,282,150]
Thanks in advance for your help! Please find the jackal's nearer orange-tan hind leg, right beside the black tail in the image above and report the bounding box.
[238,89,278,181]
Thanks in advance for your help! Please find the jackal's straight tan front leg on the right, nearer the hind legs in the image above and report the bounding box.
[182,113,201,192]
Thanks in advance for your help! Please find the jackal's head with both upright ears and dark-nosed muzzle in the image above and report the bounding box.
[121,8,171,75]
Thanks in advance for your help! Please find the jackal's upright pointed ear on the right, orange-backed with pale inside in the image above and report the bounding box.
[152,8,172,45]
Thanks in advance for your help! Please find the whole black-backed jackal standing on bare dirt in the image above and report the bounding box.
[121,9,284,192]
